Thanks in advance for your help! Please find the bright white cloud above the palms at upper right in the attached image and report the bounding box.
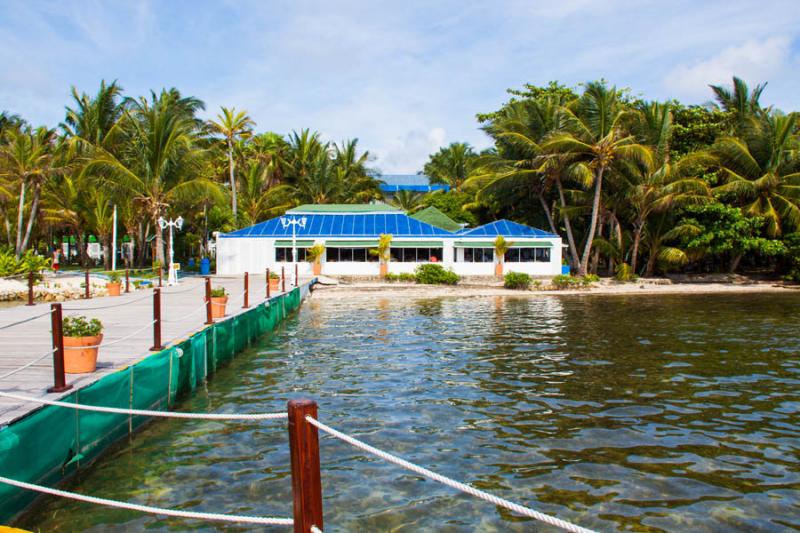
[665,37,792,98]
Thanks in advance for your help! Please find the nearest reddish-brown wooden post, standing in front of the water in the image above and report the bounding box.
[288,400,323,533]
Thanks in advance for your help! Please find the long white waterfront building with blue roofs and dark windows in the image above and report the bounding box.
[217,203,561,276]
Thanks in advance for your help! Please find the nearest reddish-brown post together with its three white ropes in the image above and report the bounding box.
[0,392,593,533]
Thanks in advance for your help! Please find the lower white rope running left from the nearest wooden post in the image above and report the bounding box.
[0,476,294,526]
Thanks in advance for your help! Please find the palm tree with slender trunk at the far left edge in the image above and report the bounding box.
[0,127,57,258]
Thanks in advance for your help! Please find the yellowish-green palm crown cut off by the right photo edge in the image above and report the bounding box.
[710,113,800,237]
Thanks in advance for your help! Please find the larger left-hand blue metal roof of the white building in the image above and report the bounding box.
[220,213,453,238]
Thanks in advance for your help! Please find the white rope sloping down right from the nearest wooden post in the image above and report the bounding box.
[306,416,594,533]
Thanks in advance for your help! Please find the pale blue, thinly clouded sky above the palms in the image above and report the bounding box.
[0,0,800,174]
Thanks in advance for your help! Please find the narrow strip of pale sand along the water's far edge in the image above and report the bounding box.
[313,280,800,299]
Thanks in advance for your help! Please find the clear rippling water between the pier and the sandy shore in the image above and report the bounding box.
[18,294,800,532]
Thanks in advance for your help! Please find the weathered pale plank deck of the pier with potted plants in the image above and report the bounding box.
[0,275,309,427]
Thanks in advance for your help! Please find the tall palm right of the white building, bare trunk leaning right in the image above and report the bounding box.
[542,82,653,276]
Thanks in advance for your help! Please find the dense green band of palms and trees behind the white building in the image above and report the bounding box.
[0,78,800,281]
